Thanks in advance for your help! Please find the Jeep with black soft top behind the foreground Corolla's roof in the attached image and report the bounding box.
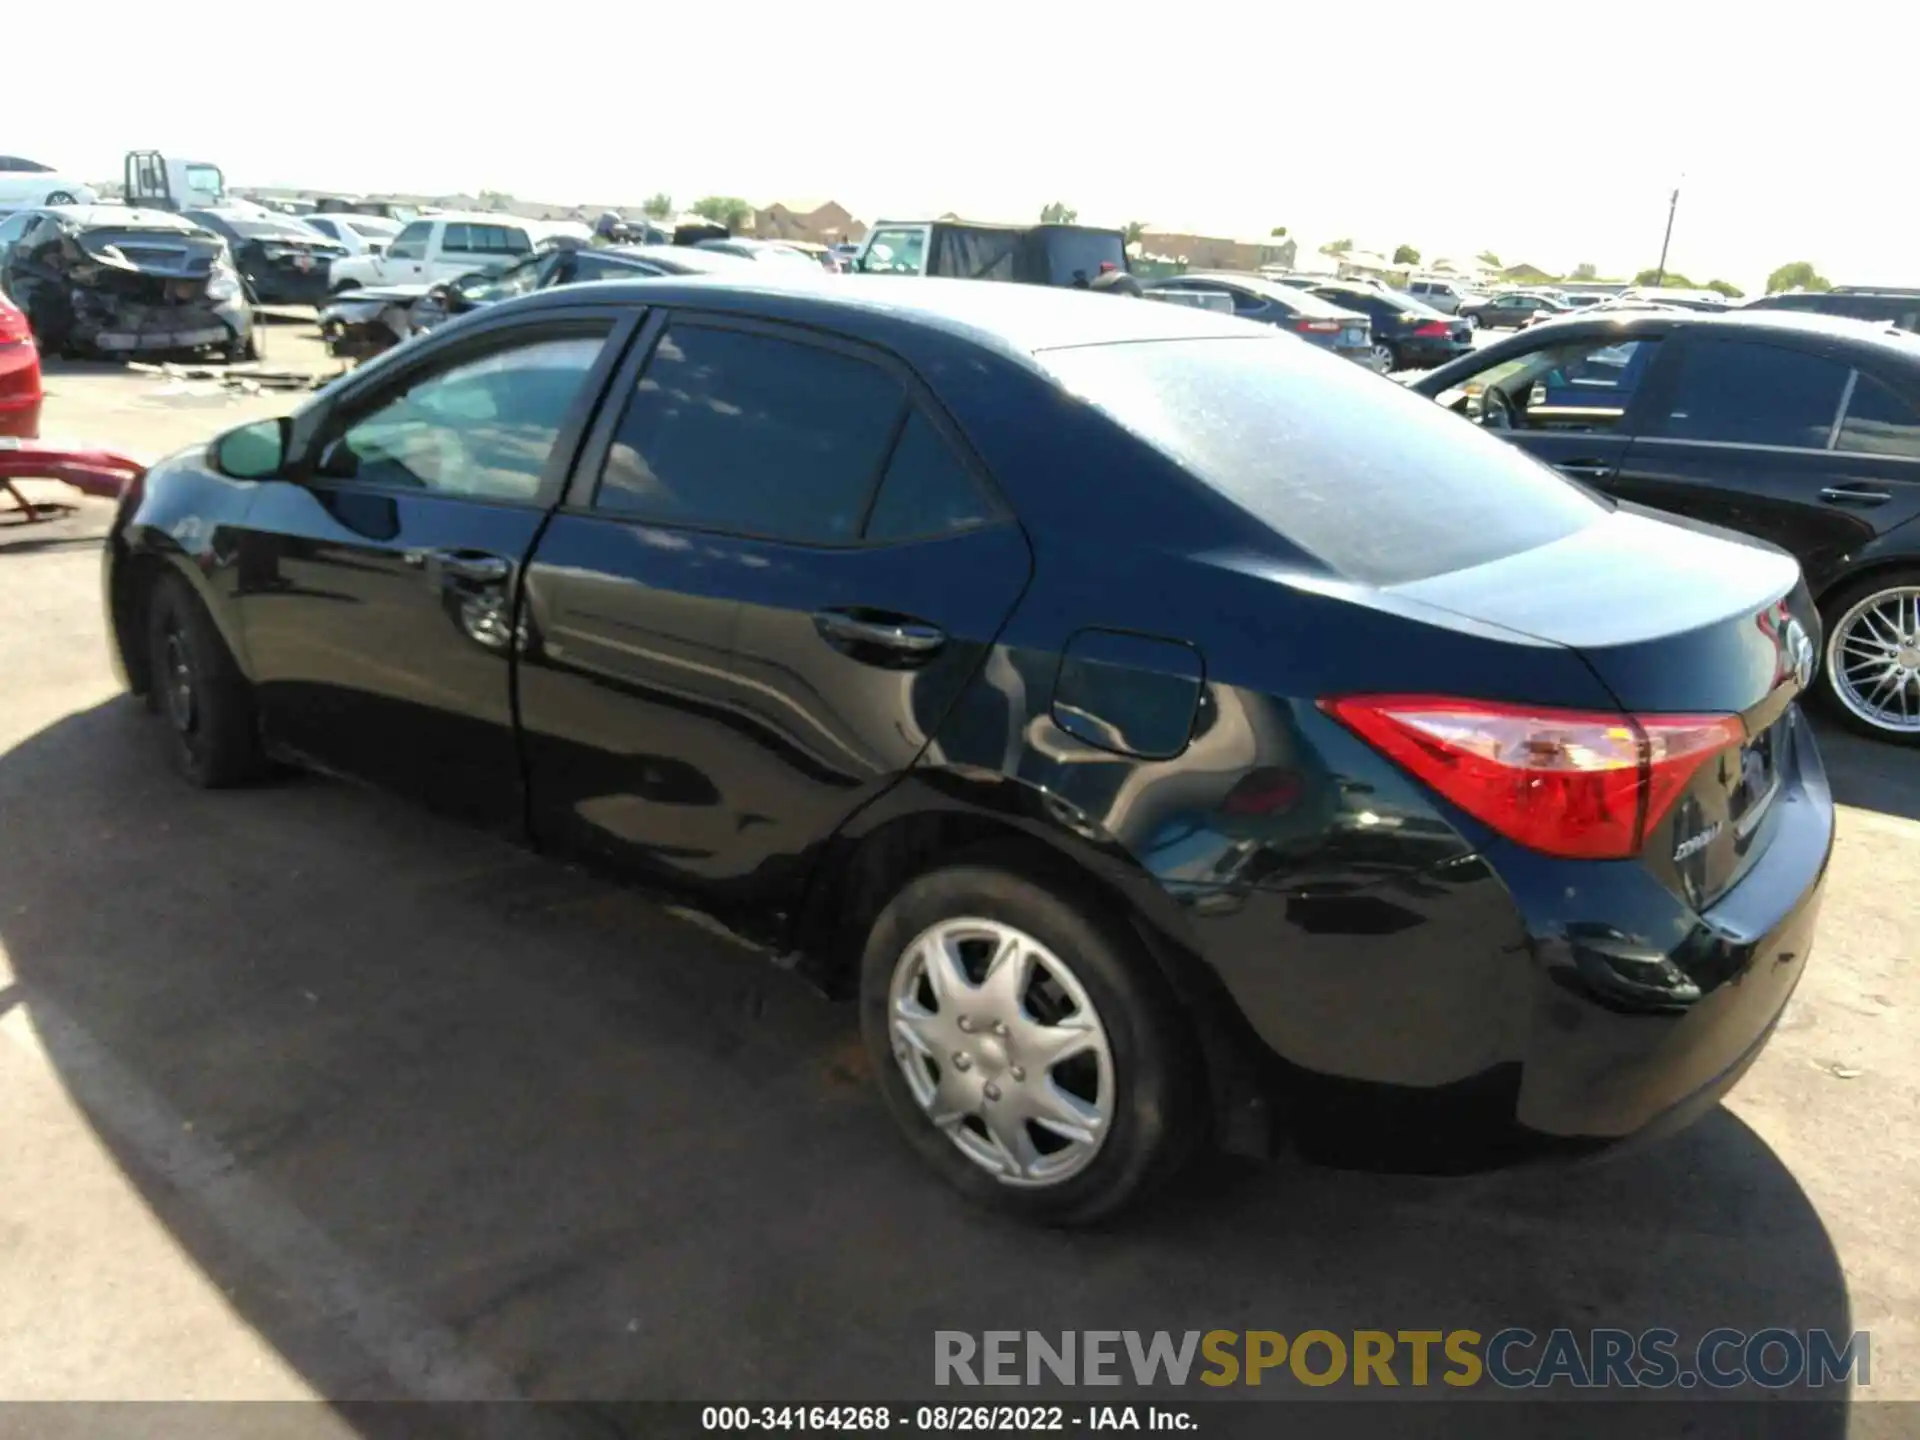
[854,221,1129,288]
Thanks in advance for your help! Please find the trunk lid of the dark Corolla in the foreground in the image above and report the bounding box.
[1394,505,1820,908]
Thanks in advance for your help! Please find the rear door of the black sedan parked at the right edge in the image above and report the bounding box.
[1617,330,1920,589]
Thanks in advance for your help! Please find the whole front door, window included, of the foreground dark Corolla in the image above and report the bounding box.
[232,309,632,831]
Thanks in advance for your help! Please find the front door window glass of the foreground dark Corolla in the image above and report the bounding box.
[315,326,607,505]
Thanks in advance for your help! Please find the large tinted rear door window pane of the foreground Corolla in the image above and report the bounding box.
[593,324,906,543]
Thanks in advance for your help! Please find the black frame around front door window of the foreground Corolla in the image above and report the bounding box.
[286,307,639,511]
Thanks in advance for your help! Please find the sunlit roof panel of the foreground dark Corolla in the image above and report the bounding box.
[501,265,1265,357]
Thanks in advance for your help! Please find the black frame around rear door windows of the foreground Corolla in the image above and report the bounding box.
[559,305,1018,551]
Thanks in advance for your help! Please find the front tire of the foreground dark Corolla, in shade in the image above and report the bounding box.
[146,574,267,789]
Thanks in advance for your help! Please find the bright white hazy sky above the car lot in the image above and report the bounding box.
[18,0,1920,288]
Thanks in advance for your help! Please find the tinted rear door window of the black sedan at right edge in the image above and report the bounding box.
[1647,340,1849,449]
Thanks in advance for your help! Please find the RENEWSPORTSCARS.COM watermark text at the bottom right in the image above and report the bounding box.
[933,1329,1872,1390]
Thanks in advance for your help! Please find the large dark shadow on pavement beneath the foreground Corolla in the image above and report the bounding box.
[0,699,1851,1436]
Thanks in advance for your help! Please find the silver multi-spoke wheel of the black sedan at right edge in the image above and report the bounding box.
[1820,570,1920,745]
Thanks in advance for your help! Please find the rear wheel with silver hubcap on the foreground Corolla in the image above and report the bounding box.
[860,862,1198,1225]
